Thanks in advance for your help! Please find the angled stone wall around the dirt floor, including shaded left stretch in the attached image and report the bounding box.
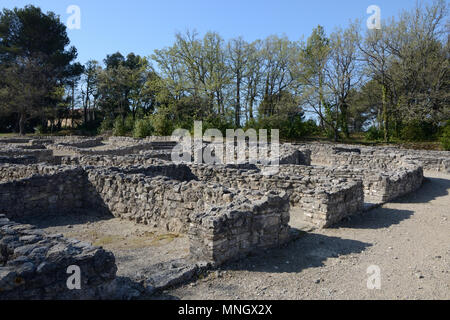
[0,164,289,264]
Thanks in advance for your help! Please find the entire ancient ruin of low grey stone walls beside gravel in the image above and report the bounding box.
[0,137,450,299]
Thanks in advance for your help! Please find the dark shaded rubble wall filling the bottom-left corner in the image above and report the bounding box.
[0,215,117,300]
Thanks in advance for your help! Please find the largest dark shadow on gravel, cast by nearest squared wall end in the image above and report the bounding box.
[221,233,372,273]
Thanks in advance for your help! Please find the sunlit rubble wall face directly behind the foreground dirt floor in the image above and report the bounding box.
[84,170,232,232]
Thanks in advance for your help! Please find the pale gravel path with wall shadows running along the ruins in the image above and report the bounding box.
[160,173,450,299]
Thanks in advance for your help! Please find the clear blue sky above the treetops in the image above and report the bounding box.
[0,0,431,63]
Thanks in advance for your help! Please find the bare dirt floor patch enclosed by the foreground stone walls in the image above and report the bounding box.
[24,213,189,278]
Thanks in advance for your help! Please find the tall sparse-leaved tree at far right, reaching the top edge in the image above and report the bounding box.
[386,0,450,127]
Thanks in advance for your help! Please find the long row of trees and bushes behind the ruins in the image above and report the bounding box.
[0,0,450,142]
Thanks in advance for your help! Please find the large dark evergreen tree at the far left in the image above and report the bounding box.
[0,5,77,134]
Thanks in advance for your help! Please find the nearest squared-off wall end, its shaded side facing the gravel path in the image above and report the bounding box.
[188,193,289,265]
